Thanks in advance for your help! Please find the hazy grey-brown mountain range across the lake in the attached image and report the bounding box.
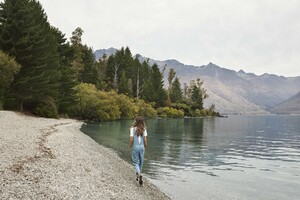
[95,48,300,114]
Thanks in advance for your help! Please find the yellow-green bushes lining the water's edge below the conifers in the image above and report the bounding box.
[74,83,172,121]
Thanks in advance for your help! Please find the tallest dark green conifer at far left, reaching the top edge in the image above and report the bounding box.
[0,0,60,111]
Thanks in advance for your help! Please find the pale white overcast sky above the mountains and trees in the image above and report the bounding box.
[36,0,300,76]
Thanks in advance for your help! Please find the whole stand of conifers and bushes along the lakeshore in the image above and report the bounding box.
[0,0,219,120]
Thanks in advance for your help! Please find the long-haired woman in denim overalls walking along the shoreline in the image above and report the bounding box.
[129,116,147,185]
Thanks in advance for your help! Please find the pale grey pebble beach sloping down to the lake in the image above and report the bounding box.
[0,111,169,199]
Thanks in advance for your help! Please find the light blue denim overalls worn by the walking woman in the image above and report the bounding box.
[132,128,147,174]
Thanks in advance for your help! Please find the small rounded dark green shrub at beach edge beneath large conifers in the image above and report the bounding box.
[34,97,58,118]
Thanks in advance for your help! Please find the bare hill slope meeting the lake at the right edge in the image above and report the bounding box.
[271,92,300,114]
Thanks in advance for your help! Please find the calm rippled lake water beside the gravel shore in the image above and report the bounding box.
[82,115,300,200]
